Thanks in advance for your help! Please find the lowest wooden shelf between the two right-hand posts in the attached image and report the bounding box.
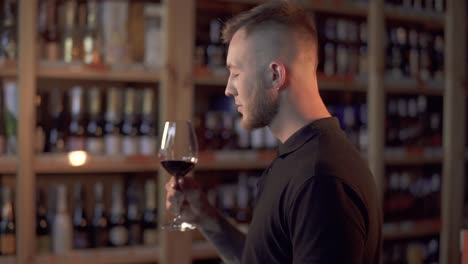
[383,219,441,240]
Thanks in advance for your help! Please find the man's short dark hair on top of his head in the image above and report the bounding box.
[222,0,317,44]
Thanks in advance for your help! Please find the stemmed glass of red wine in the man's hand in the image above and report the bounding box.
[159,120,198,231]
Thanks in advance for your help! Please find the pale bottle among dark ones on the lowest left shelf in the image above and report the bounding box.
[52,184,73,255]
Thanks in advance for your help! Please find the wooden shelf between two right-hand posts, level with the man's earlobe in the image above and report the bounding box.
[385,80,444,96]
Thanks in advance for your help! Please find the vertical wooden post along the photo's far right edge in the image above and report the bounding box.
[439,0,466,264]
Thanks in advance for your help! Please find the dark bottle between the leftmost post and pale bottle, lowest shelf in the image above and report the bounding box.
[36,189,51,255]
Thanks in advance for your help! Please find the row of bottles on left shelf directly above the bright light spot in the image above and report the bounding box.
[37,85,157,155]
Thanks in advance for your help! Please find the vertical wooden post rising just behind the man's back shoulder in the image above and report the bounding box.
[367,0,385,198]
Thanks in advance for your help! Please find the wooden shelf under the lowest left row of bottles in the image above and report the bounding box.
[33,247,159,264]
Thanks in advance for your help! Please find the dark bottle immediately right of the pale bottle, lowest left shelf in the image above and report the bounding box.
[73,183,89,249]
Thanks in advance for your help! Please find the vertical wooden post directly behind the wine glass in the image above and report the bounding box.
[158,0,195,264]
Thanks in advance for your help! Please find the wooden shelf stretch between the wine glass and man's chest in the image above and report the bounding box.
[195,150,277,170]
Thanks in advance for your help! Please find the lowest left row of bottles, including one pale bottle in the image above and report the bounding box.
[36,180,158,254]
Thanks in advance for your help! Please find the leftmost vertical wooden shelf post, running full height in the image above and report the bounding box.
[16,0,37,264]
